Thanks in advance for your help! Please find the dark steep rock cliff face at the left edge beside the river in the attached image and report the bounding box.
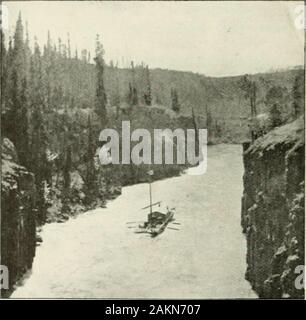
[1,138,36,297]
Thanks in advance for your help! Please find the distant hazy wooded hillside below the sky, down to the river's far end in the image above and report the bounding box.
[50,61,303,142]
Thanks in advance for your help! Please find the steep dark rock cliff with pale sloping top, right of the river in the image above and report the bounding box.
[242,118,305,298]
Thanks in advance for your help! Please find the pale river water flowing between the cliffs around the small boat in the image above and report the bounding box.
[12,145,256,298]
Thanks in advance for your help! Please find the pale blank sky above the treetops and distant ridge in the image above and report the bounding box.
[3,1,304,76]
